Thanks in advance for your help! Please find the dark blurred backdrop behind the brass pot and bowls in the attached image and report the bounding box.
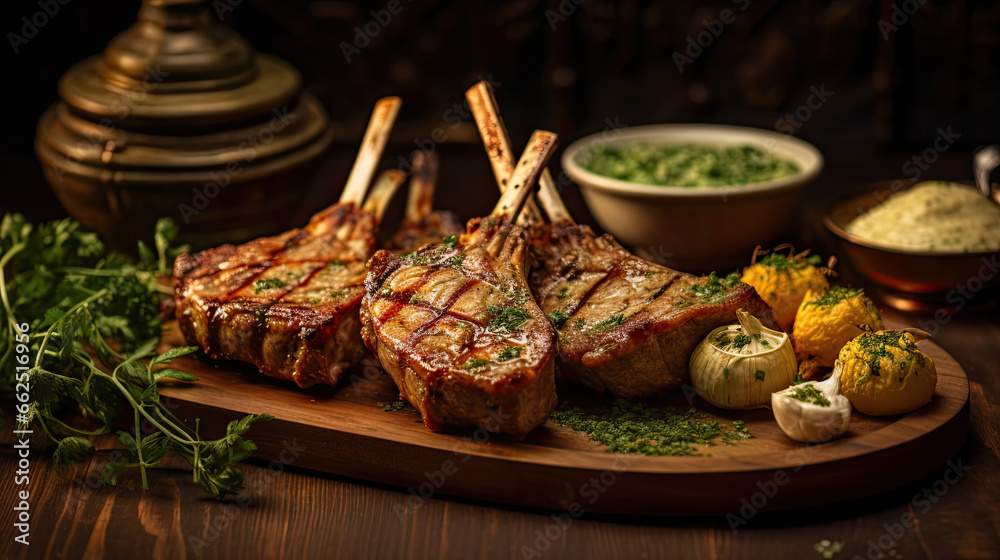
[0,0,1000,249]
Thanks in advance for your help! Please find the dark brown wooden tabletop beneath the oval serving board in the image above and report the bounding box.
[0,151,1000,560]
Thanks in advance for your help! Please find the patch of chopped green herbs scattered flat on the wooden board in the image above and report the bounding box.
[549,399,751,456]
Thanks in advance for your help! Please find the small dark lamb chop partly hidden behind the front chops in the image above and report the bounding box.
[386,151,465,253]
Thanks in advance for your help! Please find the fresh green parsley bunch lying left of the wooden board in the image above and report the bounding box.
[0,214,270,497]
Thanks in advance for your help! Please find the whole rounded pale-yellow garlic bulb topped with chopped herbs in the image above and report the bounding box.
[689,309,798,410]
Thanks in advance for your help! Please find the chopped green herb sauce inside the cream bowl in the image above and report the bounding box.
[577,143,799,187]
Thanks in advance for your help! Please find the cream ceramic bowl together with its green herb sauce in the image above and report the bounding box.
[560,124,823,272]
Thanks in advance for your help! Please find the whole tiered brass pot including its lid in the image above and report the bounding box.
[35,0,332,253]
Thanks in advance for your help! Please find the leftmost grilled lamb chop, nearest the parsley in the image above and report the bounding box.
[174,98,405,388]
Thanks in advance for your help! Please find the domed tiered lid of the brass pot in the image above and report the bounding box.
[51,0,302,134]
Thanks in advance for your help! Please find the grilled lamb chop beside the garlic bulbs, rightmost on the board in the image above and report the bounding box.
[466,82,778,397]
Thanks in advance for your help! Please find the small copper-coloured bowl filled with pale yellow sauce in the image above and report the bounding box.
[824,181,1000,310]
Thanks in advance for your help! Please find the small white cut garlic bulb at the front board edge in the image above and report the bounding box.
[771,361,851,443]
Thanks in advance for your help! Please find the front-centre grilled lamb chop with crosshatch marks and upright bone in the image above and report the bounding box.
[361,131,556,437]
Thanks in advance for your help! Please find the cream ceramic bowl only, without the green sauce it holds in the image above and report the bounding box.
[562,124,823,271]
